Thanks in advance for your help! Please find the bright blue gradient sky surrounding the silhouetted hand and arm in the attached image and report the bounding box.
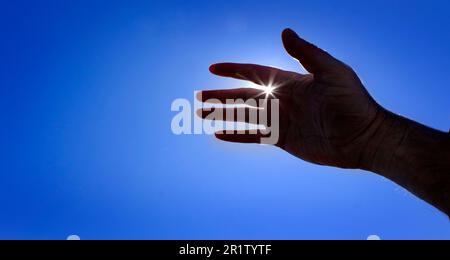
[0,0,450,239]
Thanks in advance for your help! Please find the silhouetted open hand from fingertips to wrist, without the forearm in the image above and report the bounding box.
[200,29,386,168]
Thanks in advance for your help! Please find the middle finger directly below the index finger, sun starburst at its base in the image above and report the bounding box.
[197,88,266,104]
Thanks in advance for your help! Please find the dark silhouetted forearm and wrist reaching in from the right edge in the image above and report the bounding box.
[362,107,450,216]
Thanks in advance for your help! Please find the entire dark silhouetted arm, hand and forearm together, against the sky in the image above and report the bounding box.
[198,29,450,215]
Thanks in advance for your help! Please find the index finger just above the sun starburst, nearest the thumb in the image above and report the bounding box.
[209,63,301,86]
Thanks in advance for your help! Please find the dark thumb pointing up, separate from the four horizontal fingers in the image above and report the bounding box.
[282,29,346,74]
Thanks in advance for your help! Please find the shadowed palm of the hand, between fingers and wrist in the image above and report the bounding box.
[280,69,378,168]
